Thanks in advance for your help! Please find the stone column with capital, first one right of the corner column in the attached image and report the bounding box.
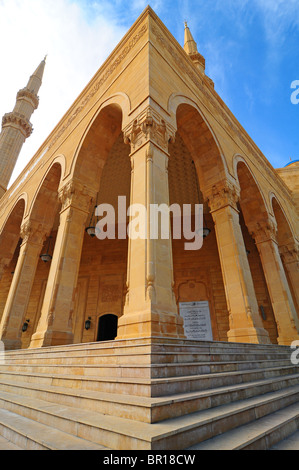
[206,182,270,344]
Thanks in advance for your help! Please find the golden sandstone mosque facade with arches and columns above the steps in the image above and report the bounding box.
[0,7,299,349]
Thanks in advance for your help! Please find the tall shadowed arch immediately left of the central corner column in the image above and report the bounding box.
[71,99,131,346]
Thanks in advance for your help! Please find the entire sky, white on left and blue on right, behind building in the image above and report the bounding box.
[0,0,299,184]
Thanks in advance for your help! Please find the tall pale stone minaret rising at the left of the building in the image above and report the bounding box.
[0,58,46,197]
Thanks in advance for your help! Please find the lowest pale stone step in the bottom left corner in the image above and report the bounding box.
[0,409,109,450]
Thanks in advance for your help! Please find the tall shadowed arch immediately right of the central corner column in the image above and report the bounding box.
[168,95,232,341]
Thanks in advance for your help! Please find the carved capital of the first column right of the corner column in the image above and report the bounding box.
[205,181,240,212]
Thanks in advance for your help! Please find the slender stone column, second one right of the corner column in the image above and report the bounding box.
[248,221,299,345]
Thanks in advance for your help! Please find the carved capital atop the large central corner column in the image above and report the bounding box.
[123,106,176,152]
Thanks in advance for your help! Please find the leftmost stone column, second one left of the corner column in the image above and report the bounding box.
[0,220,48,349]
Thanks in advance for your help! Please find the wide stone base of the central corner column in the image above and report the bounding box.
[115,313,186,340]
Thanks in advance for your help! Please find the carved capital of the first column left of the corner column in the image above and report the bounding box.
[58,180,95,212]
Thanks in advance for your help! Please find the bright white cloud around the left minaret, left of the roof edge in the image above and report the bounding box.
[0,0,126,187]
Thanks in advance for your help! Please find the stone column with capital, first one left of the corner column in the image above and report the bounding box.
[30,181,95,348]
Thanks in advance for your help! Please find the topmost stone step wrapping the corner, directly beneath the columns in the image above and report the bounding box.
[5,338,291,363]
